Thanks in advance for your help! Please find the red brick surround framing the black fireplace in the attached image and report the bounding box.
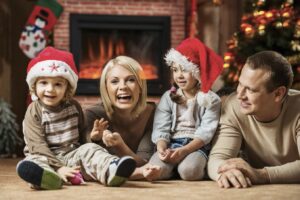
[54,0,186,107]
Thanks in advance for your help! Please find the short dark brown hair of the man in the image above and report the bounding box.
[246,51,294,92]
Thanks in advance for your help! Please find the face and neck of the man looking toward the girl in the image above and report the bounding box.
[237,65,275,121]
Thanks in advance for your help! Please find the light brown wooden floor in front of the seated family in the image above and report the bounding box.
[0,159,300,200]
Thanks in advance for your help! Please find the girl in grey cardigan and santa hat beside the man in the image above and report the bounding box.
[150,38,223,180]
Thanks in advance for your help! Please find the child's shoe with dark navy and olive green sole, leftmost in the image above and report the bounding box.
[17,160,63,190]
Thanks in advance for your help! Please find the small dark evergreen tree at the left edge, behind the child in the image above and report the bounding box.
[0,99,23,157]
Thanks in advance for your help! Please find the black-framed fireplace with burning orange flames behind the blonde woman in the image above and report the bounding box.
[70,14,170,95]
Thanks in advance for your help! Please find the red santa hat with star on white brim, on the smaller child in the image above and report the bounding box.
[26,47,78,97]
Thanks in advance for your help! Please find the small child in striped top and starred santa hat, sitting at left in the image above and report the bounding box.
[17,47,136,190]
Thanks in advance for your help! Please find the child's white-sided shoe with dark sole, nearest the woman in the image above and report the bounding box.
[107,156,136,187]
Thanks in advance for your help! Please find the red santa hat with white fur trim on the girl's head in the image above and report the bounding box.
[165,38,223,93]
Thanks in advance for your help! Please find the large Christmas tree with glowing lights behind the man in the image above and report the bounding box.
[223,0,300,89]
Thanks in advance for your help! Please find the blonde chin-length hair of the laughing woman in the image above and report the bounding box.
[100,56,147,118]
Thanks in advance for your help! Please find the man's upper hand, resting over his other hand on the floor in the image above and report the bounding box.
[218,158,269,186]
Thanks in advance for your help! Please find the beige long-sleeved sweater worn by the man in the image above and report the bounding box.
[208,90,300,183]
